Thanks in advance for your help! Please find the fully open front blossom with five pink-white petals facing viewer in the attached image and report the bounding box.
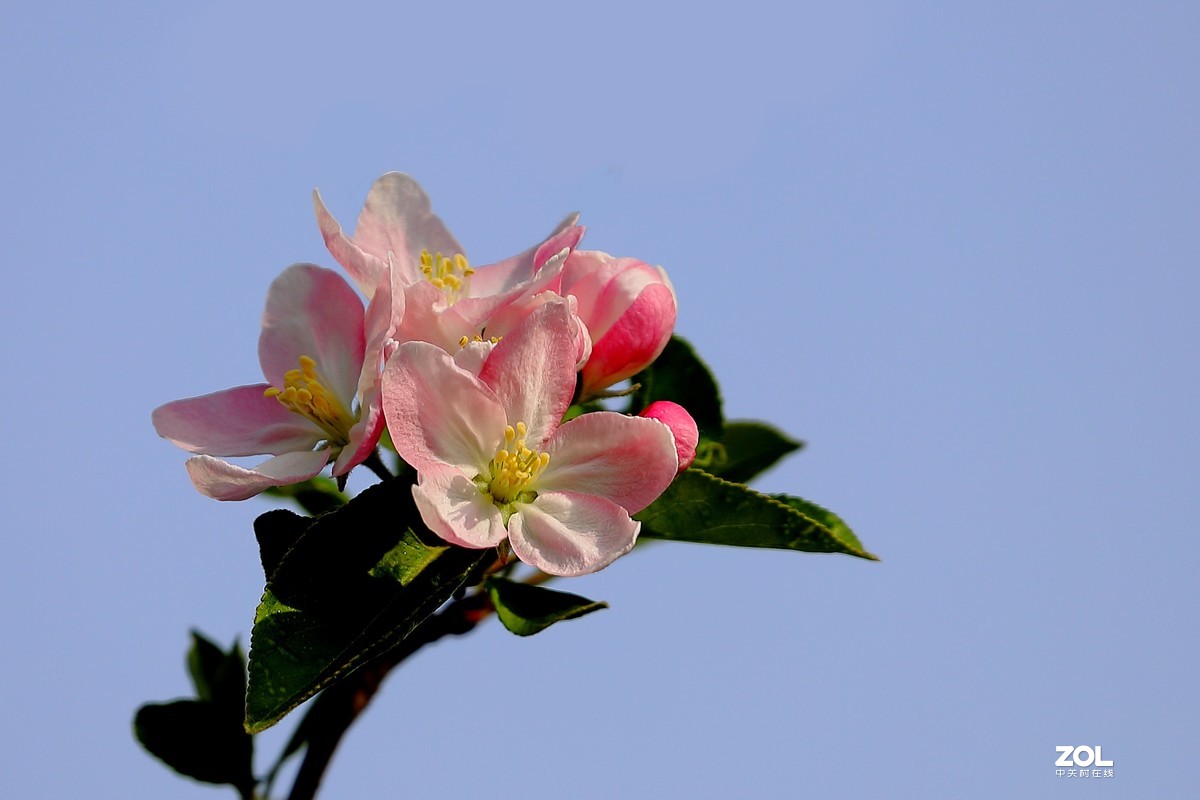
[383,300,678,576]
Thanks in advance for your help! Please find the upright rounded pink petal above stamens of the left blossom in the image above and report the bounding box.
[258,264,366,398]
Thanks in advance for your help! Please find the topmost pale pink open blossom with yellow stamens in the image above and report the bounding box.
[313,173,583,349]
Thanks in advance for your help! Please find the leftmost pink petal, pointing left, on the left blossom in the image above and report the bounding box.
[150,384,325,456]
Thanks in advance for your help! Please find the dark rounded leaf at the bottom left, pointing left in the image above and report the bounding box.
[133,700,254,796]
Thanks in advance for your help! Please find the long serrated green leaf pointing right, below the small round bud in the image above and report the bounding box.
[634,468,878,560]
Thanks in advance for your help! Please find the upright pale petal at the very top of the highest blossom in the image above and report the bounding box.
[354,173,463,283]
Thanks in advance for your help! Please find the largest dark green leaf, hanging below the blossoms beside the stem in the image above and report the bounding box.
[246,481,496,733]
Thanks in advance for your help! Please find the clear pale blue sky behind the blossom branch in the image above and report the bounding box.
[0,0,1200,800]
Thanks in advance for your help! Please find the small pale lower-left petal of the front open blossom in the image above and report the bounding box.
[413,468,509,549]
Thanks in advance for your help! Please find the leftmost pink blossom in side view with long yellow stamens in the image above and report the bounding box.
[152,264,392,500]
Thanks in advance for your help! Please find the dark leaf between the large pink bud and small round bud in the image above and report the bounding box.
[630,336,724,439]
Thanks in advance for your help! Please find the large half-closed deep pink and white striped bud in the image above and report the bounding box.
[559,249,676,401]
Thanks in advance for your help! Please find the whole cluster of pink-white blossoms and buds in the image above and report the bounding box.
[152,173,697,576]
